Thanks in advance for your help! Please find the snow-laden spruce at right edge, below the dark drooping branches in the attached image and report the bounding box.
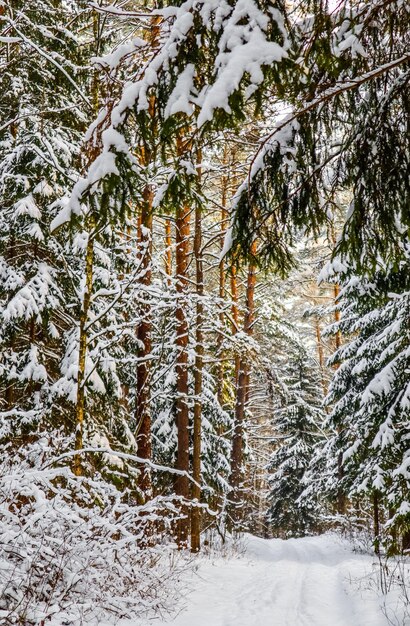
[322,246,410,549]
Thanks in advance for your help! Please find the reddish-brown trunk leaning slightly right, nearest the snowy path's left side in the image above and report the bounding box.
[230,242,256,525]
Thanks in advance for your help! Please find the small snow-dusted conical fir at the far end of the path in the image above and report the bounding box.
[267,324,324,536]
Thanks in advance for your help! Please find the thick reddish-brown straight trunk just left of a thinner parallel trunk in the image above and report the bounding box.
[175,186,190,548]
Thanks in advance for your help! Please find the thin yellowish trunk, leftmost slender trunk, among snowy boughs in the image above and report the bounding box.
[73,220,95,476]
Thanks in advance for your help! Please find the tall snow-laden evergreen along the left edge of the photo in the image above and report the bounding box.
[0,0,88,434]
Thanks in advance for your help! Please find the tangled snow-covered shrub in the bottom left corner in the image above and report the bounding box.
[0,440,186,626]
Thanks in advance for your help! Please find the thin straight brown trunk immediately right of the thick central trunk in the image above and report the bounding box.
[191,160,204,552]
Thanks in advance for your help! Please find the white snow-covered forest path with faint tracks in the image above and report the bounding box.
[138,535,410,626]
